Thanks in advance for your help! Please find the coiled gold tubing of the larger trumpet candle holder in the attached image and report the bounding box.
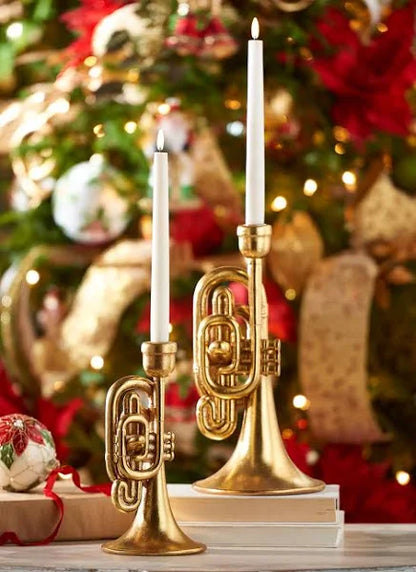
[194,260,272,440]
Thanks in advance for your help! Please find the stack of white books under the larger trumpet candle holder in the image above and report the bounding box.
[168,485,344,548]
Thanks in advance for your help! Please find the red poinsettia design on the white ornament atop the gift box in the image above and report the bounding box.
[0,413,47,456]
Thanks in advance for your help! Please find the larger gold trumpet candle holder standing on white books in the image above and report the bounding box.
[193,224,325,495]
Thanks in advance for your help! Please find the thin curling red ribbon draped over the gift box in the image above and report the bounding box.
[0,465,111,546]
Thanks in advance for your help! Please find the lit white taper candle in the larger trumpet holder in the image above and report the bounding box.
[246,18,264,224]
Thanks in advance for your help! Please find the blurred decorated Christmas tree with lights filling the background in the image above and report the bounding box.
[0,0,416,522]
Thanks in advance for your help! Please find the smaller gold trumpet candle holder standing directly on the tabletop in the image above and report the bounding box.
[102,342,206,555]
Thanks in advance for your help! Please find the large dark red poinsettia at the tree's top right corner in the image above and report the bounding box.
[310,6,416,141]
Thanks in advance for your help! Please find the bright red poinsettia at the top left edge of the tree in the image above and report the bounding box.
[62,0,129,67]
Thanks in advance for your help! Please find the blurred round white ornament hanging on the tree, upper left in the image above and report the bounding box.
[53,160,129,244]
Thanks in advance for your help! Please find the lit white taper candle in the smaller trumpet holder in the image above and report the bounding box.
[150,131,170,343]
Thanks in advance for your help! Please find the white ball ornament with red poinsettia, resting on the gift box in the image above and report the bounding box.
[0,413,59,491]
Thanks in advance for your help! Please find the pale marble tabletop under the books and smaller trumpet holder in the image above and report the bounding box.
[0,524,416,572]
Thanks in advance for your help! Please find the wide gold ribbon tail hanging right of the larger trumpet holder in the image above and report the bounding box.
[299,253,388,443]
